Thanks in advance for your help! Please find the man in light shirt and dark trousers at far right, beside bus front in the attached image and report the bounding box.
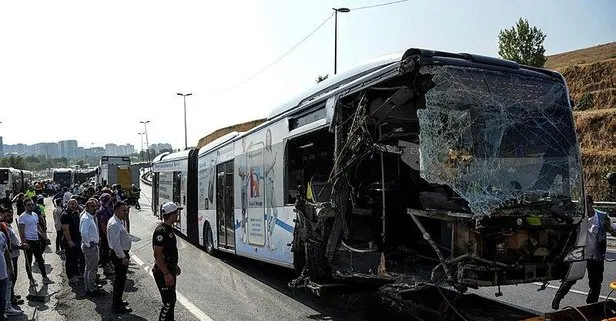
[552,195,616,310]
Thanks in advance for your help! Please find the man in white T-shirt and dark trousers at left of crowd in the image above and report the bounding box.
[17,198,54,286]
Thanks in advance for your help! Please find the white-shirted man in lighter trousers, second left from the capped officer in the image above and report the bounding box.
[79,199,104,296]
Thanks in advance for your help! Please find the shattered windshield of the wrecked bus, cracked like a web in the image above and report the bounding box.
[418,66,581,216]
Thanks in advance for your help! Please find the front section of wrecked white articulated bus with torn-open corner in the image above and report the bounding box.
[153,49,585,292]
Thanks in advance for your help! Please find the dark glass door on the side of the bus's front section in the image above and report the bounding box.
[216,160,235,249]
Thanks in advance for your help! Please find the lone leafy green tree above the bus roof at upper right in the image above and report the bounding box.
[498,18,547,67]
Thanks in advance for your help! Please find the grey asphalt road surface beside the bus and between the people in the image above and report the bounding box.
[12,182,616,321]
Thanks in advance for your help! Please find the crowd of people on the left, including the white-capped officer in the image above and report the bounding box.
[0,181,181,321]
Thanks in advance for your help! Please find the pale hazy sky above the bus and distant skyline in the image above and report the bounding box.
[0,0,616,149]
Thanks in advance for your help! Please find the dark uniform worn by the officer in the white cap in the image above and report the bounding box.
[152,223,178,320]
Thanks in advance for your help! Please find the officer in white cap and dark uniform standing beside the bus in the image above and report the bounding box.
[152,202,182,321]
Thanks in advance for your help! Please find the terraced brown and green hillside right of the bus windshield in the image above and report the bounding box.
[545,42,616,201]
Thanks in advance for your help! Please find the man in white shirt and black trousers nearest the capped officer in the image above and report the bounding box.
[107,201,132,313]
